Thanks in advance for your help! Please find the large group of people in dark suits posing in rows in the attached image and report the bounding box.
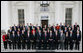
[2,23,81,50]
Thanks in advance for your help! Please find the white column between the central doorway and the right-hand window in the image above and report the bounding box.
[55,1,63,24]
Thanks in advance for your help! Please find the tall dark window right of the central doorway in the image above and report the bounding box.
[65,8,72,25]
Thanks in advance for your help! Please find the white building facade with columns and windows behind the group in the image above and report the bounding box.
[1,1,82,32]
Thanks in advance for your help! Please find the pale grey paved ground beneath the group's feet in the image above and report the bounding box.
[1,33,82,52]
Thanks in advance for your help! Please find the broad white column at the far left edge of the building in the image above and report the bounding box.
[1,1,9,32]
